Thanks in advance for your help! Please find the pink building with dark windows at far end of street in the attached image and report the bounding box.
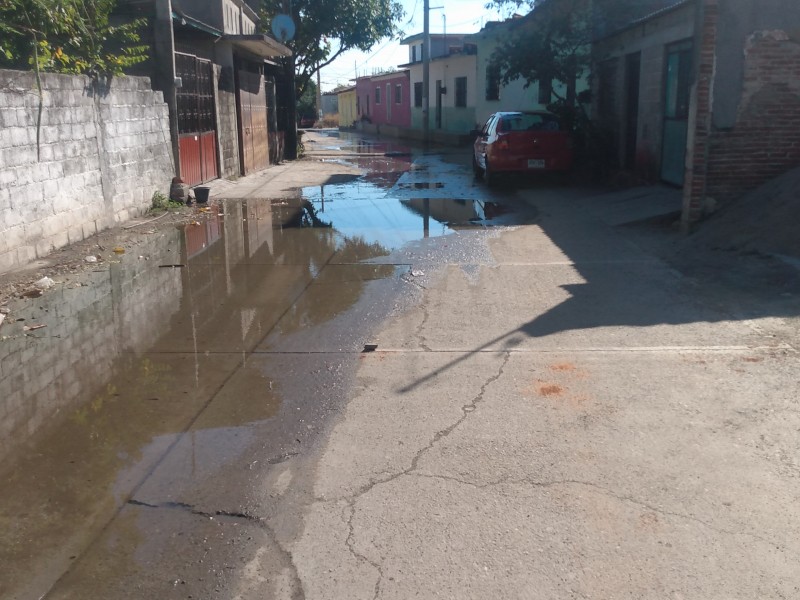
[356,70,411,127]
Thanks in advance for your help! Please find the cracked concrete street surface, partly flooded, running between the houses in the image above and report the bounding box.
[0,135,800,600]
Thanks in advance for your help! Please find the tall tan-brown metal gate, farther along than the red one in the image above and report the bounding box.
[238,71,269,175]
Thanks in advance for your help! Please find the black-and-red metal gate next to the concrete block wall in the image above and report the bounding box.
[175,52,219,185]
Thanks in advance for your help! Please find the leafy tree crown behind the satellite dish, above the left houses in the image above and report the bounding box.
[261,0,403,98]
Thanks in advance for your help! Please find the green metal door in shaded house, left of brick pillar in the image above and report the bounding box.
[661,41,692,186]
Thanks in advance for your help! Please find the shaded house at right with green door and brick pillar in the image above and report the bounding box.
[593,0,800,230]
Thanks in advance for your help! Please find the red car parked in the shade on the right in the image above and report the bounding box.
[472,111,573,185]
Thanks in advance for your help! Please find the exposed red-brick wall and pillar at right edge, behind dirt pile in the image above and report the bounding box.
[682,0,800,230]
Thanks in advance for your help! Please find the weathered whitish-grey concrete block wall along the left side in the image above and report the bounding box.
[0,70,174,273]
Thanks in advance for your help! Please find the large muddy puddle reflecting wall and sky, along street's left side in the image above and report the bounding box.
[0,146,536,598]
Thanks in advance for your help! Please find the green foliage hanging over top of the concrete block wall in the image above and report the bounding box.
[0,0,149,76]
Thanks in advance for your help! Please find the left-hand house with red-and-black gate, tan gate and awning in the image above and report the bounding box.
[117,0,291,185]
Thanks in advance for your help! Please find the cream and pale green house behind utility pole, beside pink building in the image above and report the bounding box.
[400,33,477,142]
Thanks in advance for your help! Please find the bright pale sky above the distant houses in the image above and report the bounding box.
[320,0,510,92]
